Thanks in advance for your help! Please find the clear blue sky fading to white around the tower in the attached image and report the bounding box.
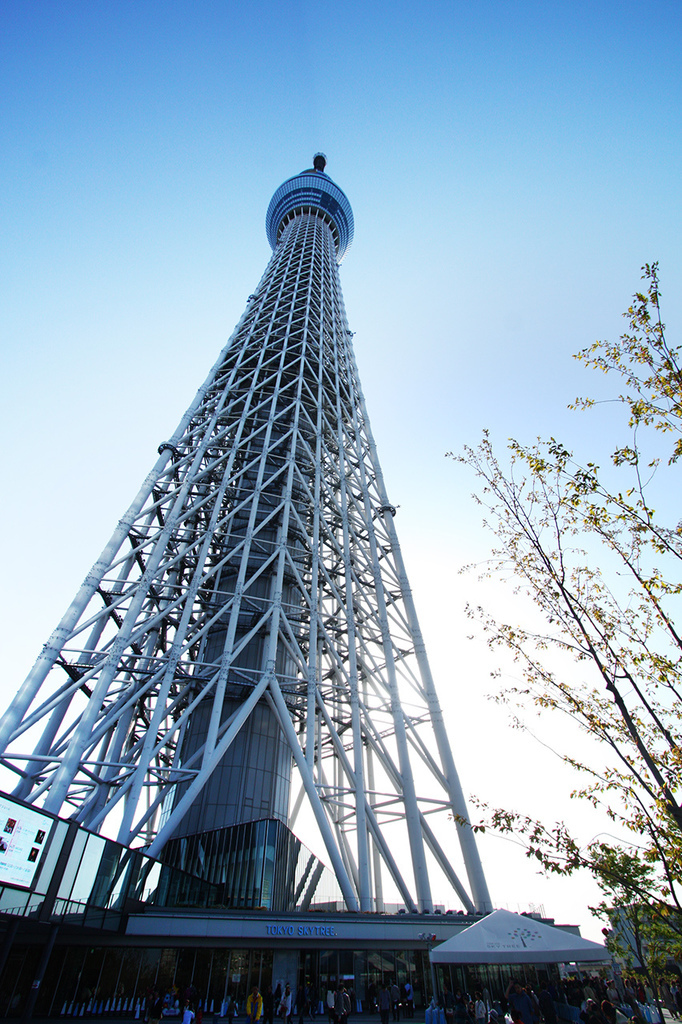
[0,0,682,937]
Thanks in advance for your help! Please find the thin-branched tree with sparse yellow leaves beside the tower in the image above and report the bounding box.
[458,263,682,991]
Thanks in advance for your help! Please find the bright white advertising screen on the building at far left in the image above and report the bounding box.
[0,797,54,889]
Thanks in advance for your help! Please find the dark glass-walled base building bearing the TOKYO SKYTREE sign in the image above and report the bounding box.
[0,798,557,1020]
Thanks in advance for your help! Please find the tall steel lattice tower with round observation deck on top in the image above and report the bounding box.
[0,154,492,911]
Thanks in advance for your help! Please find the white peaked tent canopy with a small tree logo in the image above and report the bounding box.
[430,910,611,964]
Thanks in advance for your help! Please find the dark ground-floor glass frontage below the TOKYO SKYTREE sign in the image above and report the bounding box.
[0,945,430,1020]
